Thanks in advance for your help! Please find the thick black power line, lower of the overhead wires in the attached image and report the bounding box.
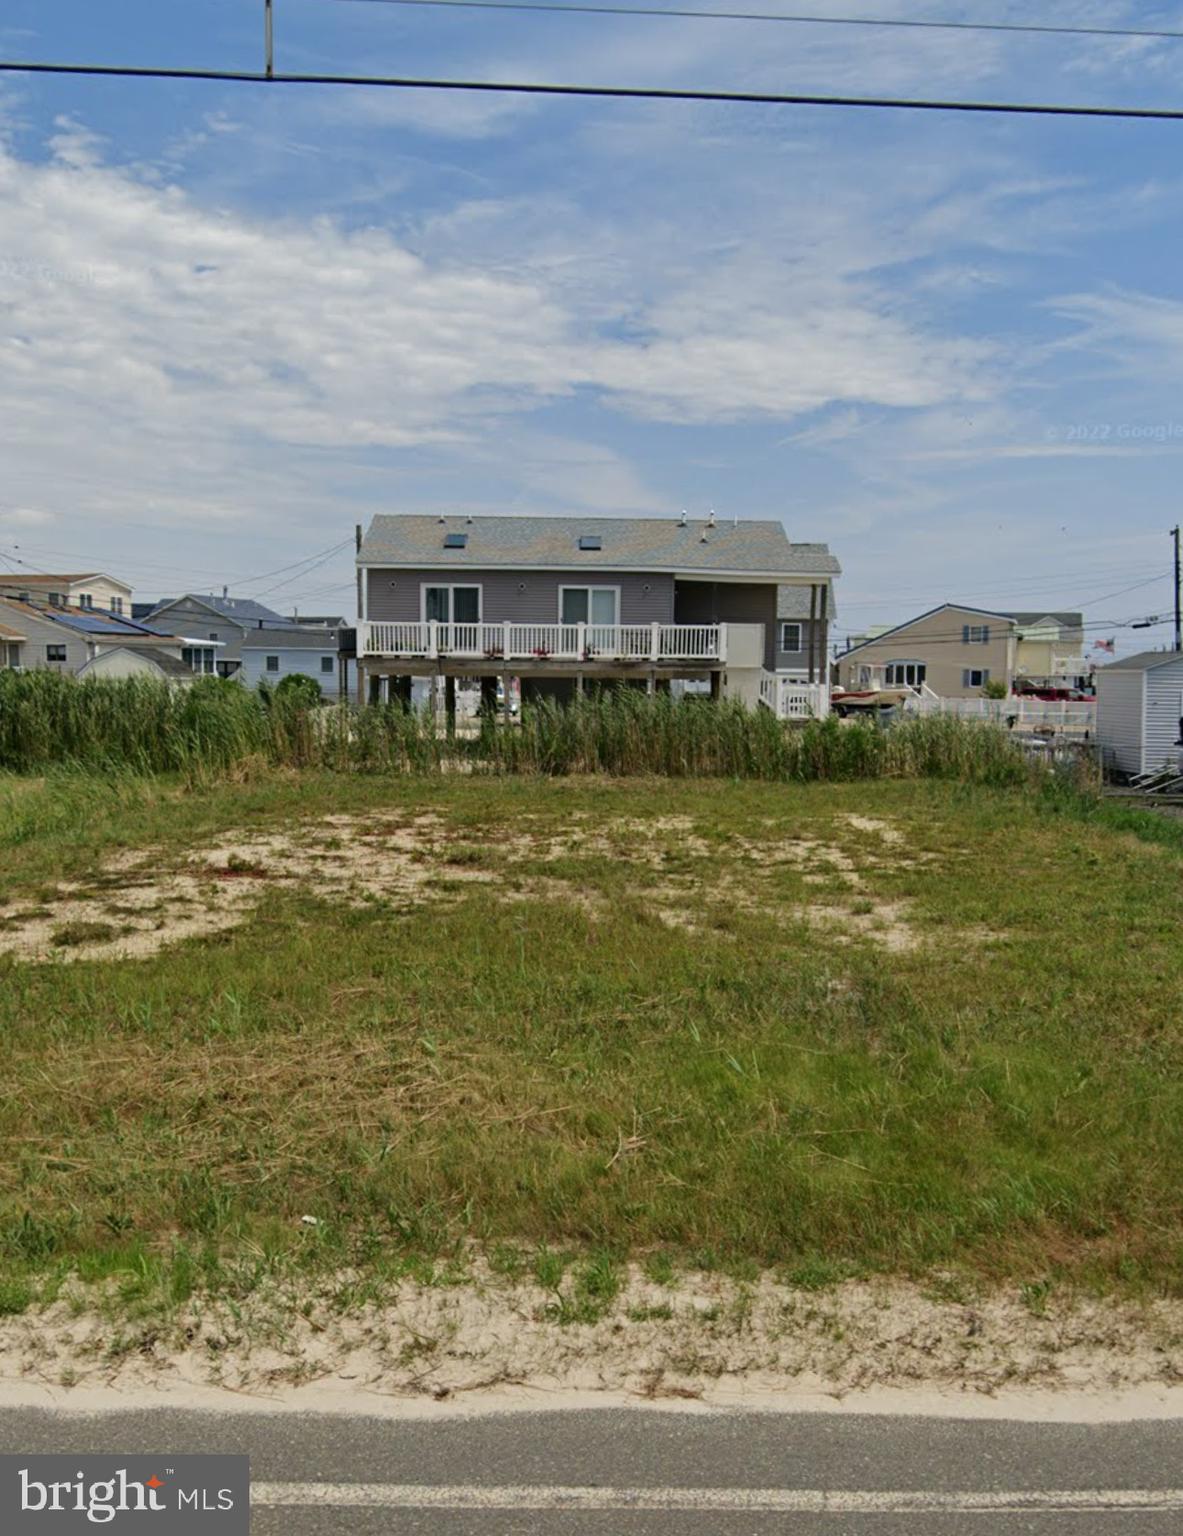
[0,58,1183,123]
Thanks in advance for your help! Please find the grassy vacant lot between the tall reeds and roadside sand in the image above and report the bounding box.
[0,773,1183,1310]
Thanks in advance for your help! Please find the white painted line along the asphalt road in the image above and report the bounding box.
[250,1482,1183,1514]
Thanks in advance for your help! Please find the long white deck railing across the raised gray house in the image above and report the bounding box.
[358,619,727,662]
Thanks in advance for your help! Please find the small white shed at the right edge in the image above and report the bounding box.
[1095,651,1183,776]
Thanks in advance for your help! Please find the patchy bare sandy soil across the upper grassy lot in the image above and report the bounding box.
[0,813,964,963]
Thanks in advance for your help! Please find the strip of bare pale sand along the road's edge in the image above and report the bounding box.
[0,1264,1183,1399]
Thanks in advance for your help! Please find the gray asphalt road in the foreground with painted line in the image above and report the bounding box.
[0,1409,1183,1536]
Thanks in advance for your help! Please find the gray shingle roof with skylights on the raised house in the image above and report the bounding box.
[358,515,842,578]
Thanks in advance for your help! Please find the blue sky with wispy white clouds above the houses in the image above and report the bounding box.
[0,0,1183,650]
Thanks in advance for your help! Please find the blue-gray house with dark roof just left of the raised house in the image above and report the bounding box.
[149,590,340,697]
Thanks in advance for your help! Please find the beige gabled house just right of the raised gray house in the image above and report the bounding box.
[836,602,1017,699]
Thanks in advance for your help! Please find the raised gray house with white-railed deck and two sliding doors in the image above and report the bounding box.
[358,513,840,702]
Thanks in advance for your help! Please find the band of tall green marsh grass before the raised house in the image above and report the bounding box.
[0,671,1042,785]
